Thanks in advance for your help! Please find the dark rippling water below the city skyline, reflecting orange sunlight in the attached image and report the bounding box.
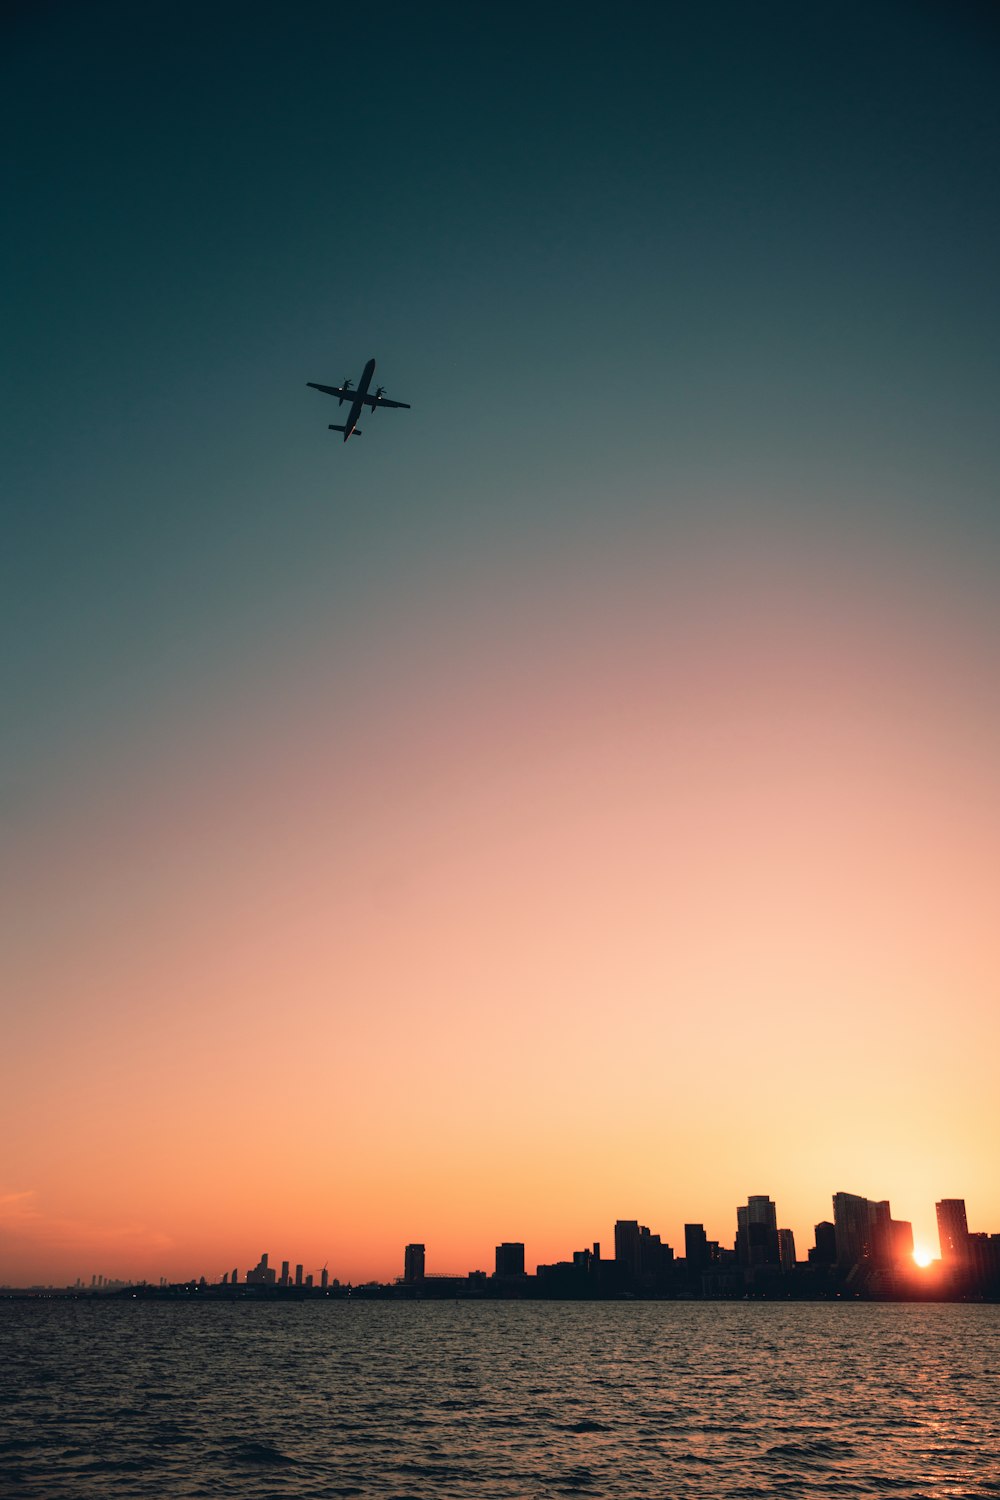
[0,1301,1000,1500]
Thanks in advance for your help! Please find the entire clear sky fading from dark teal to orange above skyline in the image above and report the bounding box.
[0,0,1000,1284]
